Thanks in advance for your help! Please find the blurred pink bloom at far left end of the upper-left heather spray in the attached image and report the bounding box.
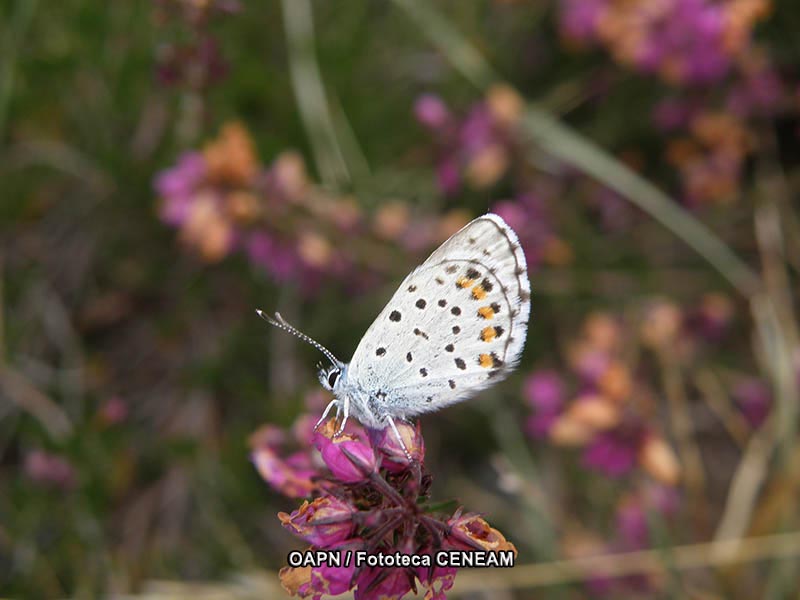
[155,152,206,226]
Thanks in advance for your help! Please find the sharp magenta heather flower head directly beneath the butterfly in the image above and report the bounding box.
[252,417,516,600]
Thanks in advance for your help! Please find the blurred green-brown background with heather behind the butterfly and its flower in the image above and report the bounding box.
[0,0,800,599]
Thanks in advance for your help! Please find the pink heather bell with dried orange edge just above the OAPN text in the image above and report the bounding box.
[278,496,355,548]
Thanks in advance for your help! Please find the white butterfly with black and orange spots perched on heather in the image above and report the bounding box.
[256,213,530,448]
